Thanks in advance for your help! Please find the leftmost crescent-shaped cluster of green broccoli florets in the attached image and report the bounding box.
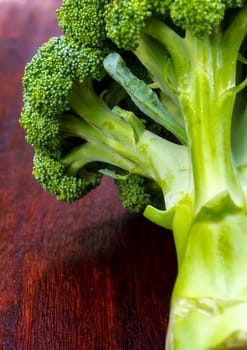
[20,37,109,202]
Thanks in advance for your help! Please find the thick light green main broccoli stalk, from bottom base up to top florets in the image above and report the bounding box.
[163,6,247,350]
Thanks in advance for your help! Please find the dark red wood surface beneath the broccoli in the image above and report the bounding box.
[0,0,176,350]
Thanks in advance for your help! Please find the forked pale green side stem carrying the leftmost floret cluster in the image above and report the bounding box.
[60,85,190,185]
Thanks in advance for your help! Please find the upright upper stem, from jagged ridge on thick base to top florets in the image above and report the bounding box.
[142,6,247,211]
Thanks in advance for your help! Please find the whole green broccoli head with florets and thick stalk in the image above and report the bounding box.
[20,0,247,350]
